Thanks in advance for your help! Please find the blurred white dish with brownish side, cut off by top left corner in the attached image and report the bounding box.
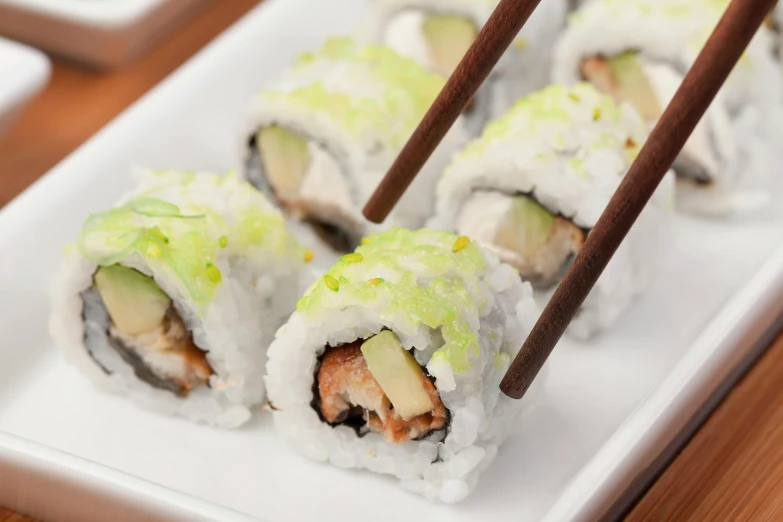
[0,0,211,68]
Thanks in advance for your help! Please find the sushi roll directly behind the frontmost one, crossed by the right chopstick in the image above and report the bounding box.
[430,83,673,339]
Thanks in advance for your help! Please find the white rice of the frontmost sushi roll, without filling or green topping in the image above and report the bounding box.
[267,226,541,503]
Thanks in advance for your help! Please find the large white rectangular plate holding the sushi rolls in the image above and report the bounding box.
[0,0,783,522]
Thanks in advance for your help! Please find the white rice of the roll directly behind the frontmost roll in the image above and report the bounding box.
[429,84,673,339]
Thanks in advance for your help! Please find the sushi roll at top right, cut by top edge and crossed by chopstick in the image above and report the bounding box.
[553,0,783,215]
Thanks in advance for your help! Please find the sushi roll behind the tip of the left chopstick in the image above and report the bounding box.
[243,38,467,253]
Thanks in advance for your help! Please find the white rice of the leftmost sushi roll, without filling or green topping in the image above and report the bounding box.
[50,172,308,428]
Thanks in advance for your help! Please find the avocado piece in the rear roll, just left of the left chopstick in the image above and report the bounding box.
[422,15,478,77]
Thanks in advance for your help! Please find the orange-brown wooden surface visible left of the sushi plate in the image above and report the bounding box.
[0,0,260,522]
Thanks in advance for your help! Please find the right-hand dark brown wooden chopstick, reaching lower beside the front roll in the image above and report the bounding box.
[500,0,775,399]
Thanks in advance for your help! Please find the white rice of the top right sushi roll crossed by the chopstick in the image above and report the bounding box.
[553,0,783,215]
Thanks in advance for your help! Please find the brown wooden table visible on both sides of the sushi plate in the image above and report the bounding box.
[0,0,783,522]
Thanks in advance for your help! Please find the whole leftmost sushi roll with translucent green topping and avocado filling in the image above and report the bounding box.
[50,171,311,428]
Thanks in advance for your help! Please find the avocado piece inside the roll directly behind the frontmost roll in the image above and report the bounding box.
[494,196,555,259]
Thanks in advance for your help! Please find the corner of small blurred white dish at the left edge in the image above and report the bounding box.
[0,38,52,133]
